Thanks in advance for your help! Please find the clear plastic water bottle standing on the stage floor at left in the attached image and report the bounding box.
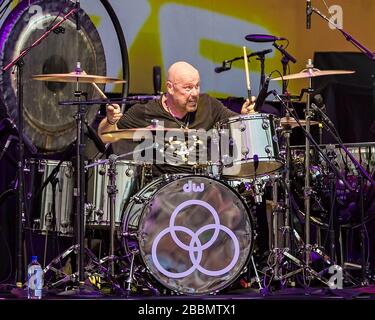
[27,256,44,299]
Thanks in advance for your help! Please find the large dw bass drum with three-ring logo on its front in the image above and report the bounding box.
[121,175,255,295]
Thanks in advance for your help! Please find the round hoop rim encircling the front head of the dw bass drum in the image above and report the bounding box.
[121,173,257,296]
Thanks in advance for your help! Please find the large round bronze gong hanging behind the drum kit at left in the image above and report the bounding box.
[0,0,106,153]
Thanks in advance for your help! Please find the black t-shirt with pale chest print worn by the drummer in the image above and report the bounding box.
[117,94,238,176]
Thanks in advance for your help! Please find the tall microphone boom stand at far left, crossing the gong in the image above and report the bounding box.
[2,8,77,288]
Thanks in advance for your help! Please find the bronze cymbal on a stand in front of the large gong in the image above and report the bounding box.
[32,72,126,83]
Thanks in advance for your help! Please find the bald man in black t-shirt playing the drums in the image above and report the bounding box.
[98,61,255,143]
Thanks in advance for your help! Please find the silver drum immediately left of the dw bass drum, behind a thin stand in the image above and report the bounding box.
[86,160,144,228]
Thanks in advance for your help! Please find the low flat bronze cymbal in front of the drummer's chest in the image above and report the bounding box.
[102,127,197,141]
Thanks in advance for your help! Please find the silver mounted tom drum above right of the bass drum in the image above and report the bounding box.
[219,113,282,179]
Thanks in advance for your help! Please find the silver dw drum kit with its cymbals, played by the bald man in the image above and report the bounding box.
[23,62,364,295]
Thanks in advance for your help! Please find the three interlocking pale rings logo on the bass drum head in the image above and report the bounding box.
[151,200,240,278]
